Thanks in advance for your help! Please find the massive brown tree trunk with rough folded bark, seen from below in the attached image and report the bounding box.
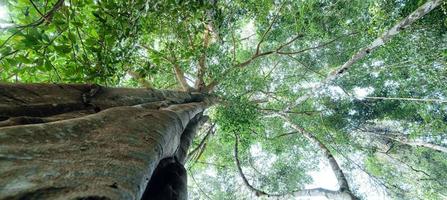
[0,84,212,199]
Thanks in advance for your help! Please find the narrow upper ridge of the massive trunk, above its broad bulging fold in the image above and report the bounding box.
[0,84,203,119]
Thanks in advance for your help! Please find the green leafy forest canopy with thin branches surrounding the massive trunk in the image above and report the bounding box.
[0,0,447,199]
